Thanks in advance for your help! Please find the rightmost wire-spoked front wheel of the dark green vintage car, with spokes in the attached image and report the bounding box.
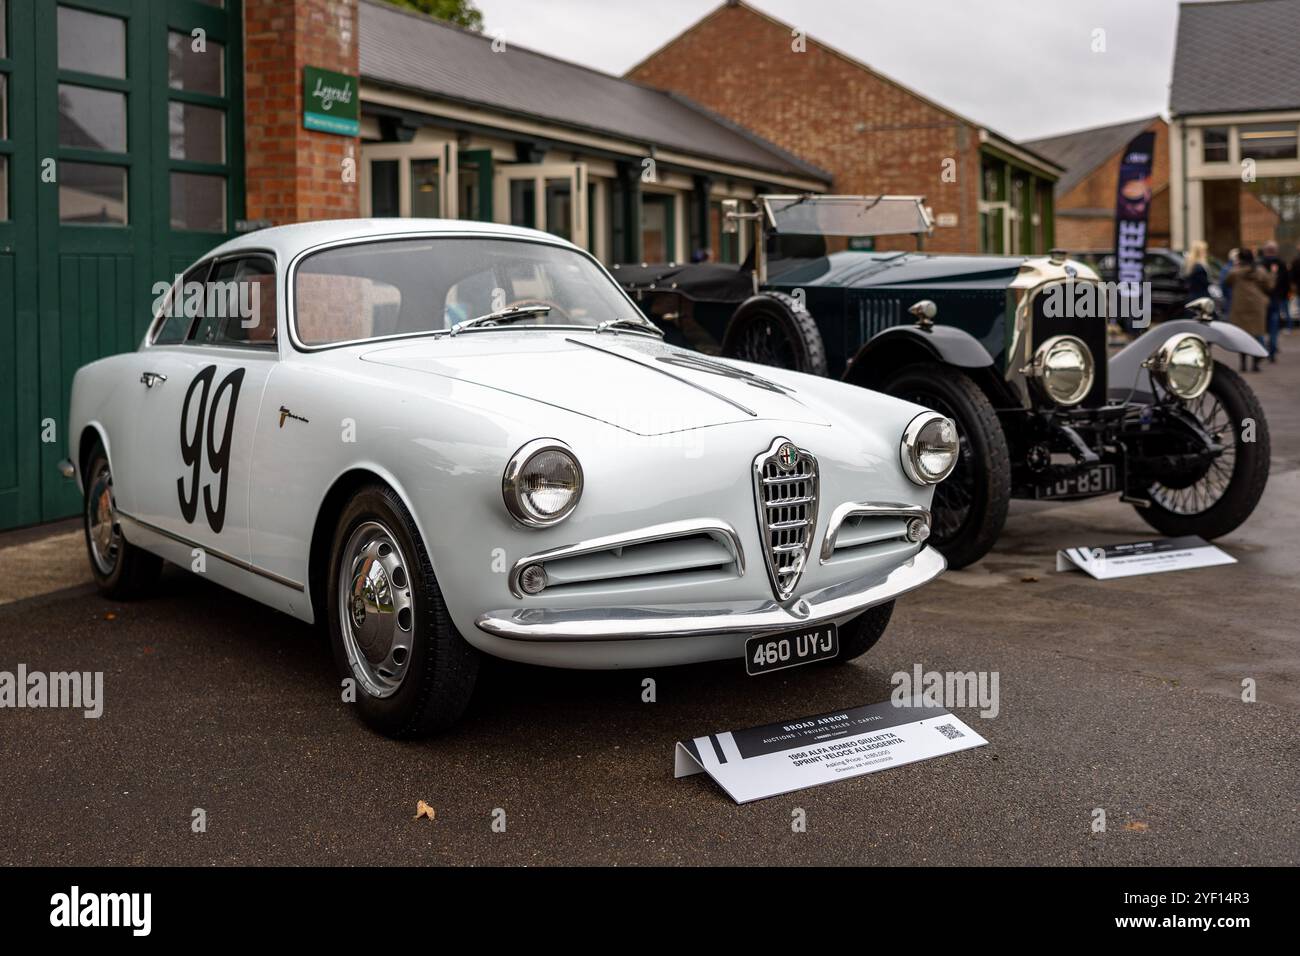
[1136,362,1271,538]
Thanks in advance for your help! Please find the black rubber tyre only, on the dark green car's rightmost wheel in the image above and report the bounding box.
[1135,362,1271,538]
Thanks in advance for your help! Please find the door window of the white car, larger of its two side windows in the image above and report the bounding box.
[191,255,277,347]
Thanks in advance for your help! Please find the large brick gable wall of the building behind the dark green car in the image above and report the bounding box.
[629,5,980,252]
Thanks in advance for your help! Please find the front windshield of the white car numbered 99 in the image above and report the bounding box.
[294,237,642,346]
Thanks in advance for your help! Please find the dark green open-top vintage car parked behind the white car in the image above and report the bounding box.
[615,196,1269,567]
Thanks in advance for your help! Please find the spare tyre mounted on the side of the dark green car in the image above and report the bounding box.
[722,291,828,376]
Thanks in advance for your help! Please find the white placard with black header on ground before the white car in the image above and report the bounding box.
[673,701,988,804]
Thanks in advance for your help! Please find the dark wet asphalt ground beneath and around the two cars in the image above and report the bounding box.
[0,345,1300,866]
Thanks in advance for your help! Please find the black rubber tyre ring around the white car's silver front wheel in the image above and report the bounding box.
[325,484,478,739]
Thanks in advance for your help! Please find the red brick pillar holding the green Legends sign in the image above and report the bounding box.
[244,0,360,224]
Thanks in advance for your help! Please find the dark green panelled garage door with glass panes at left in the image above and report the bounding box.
[0,0,243,528]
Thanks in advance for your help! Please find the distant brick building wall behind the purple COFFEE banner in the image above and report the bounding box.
[1056,120,1169,250]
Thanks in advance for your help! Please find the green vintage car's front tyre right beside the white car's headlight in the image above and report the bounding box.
[880,362,1011,570]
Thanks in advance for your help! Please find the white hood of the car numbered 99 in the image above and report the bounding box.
[360,329,831,436]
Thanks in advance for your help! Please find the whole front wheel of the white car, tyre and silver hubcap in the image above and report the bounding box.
[325,484,478,737]
